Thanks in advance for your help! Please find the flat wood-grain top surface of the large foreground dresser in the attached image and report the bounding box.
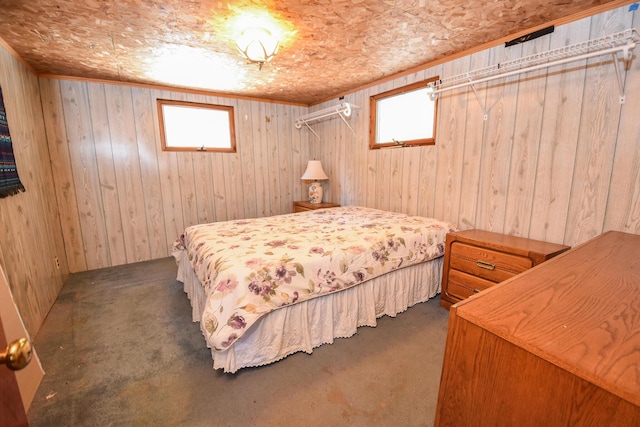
[454,232,640,406]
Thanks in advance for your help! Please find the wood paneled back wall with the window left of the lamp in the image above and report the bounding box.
[40,79,310,272]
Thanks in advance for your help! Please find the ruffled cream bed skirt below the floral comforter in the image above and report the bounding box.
[177,251,444,373]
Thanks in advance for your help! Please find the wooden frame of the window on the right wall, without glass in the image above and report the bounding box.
[369,76,440,150]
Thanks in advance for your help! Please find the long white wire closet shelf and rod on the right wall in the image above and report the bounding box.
[427,28,640,105]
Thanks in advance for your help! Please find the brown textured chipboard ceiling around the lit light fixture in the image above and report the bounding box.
[0,0,631,104]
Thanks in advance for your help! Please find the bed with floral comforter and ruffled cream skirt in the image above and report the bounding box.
[172,206,456,373]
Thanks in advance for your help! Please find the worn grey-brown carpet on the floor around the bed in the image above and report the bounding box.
[28,258,448,426]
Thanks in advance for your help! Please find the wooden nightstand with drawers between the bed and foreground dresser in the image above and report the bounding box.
[440,230,569,307]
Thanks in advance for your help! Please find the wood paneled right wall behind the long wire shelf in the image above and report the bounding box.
[312,6,640,246]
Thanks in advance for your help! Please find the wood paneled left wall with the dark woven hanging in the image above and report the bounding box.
[0,45,69,336]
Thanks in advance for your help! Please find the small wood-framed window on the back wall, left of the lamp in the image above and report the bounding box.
[158,99,236,153]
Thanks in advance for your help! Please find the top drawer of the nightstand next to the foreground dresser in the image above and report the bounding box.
[450,242,533,283]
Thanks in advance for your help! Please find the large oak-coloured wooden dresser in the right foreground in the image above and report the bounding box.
[435,232,640,427]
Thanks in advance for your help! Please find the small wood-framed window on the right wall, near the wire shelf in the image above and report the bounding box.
[369,77,438,149]
